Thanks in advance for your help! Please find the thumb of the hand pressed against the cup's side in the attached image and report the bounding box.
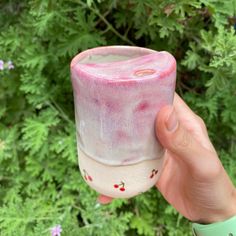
[156,106,213,170]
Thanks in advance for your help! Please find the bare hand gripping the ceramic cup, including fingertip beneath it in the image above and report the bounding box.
[99,94,236,223]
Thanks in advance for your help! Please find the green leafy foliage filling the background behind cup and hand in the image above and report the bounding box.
[0,0,236,236]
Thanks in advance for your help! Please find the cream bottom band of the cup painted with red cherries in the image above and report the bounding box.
[78,150,163,198]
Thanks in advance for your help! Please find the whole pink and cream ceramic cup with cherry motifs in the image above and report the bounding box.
[71,46,176,198]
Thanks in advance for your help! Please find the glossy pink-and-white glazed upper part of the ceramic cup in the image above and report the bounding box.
[71,46,176,165]
